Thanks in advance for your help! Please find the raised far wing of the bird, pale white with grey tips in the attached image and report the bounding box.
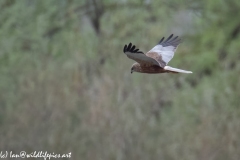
[146,34,182,68]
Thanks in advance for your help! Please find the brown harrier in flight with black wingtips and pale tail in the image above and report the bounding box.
[123,34,192,74]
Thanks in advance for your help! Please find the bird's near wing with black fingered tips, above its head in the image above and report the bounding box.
[123,43,159,66]
